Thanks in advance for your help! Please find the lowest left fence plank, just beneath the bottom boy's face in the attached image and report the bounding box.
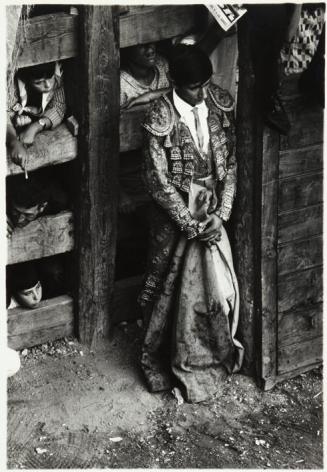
[7,295,74,349]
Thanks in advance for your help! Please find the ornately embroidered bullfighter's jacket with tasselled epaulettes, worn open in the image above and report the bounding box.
[143,84,236,239]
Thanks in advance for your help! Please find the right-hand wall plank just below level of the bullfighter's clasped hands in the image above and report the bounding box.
[278,235,323,276]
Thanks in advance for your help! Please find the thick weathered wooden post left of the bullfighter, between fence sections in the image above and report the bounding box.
[76,5,119,348]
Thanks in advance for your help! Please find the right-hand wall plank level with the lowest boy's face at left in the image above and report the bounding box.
[278,267,323,313]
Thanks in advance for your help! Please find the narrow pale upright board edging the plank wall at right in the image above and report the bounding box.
[261,128,279,378]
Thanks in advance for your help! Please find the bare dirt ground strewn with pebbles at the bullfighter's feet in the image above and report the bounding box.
[8,322,323,469]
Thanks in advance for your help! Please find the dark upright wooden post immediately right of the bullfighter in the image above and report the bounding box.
[233,17,257,373]
